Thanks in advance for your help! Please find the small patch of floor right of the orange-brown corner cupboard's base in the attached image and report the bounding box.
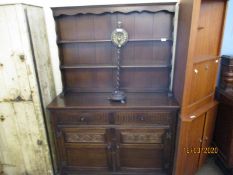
[196,158,224,175]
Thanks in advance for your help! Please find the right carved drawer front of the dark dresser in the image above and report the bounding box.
[115,111,172,125]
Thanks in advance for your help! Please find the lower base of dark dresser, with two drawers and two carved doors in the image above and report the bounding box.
[50,104,176,174]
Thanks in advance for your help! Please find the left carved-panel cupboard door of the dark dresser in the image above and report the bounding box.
[58,128,112,170]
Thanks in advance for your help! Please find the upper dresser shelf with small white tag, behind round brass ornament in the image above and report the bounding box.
[57,37,173,44]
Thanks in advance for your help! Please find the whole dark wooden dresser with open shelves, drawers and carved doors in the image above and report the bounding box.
[48,3,179,175]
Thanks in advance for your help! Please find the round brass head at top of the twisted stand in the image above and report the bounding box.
[111,21,128,48]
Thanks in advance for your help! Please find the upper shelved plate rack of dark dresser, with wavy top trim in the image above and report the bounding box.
[53,4,174,92]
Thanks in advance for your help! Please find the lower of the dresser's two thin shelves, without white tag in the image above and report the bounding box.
[60,65,171,69]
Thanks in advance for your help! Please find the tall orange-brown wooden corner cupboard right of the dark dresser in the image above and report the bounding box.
[173,0,227,175]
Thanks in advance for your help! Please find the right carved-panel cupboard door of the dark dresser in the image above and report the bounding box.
[116,128,171,171]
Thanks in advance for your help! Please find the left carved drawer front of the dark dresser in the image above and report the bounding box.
[53,110,109,125]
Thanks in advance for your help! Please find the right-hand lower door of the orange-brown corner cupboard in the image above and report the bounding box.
[199,105,217,167]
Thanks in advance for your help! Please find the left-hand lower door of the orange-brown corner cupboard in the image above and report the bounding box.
[184,114,205,175]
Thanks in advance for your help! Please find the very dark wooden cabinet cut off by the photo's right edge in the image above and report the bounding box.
[214,56,233,175]
